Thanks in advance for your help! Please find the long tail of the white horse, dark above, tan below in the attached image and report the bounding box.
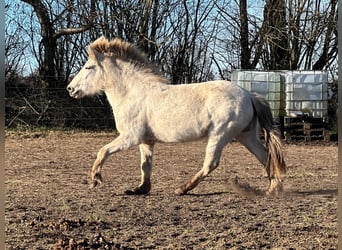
[251,94,286,179]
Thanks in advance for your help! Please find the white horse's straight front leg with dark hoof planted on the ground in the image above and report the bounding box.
[125,144,154,195]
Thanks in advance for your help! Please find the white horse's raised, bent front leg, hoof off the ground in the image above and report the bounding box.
[90,135,134,188]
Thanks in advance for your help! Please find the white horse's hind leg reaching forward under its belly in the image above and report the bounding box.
[175,137,229,195]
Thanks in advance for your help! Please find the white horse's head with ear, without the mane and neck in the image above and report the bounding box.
[67,38,106,98]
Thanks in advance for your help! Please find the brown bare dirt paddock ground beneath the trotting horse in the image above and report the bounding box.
[5,132,338,249]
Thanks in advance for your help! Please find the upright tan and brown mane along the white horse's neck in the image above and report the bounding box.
[88,37,167,83]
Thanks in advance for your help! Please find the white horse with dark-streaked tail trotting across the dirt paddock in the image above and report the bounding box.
[67,37,286,195]
